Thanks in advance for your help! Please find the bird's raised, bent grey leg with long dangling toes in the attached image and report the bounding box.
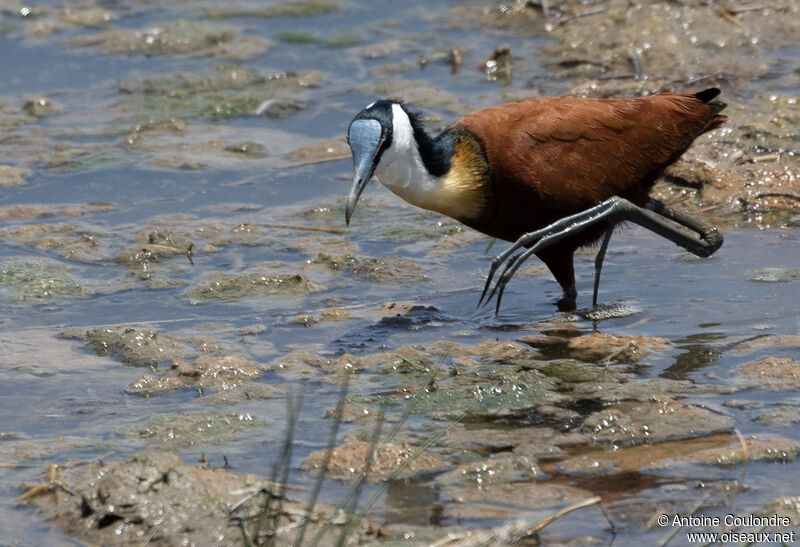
[478,196,723,312]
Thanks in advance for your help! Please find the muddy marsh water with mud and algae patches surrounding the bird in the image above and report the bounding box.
[0,1,800,545]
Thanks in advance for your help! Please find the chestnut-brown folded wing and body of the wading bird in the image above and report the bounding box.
[455,90,724,239]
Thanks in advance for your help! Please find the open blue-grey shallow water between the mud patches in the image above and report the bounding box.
[0,2,800,545]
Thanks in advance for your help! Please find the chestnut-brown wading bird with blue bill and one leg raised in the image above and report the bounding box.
[345,88,727,313]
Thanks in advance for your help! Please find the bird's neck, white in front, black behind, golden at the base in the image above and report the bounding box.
[375,105,486,221]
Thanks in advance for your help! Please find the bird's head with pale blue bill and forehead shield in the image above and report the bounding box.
[345,100,399,225]
